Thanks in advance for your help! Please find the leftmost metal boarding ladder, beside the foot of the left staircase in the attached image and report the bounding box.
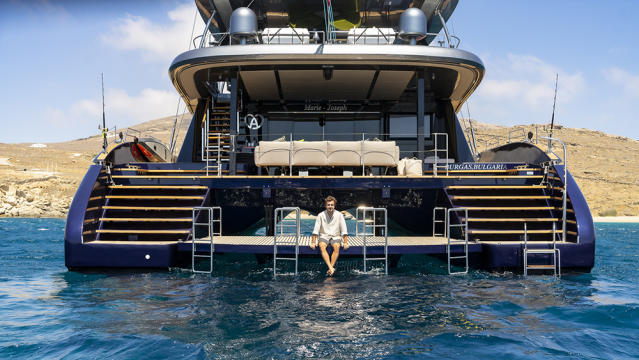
[191,206,222,274]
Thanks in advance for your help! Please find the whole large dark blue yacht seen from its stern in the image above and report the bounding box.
[65,0,595,274]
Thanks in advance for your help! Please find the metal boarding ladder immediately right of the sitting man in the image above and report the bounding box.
[355,207,388,275]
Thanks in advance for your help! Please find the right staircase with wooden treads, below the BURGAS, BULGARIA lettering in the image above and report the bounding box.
[445,168,577,242]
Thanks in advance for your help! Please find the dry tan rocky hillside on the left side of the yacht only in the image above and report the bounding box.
[0,114,191,217]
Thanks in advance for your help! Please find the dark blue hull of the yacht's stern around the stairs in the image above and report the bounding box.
[65,163,595,271]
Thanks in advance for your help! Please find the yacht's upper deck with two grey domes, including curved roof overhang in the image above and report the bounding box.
[169,0,485,112]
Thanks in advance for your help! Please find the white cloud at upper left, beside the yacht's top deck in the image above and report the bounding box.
[102,3,204,62]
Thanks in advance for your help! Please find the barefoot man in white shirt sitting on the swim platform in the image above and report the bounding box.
[311,196,349,276]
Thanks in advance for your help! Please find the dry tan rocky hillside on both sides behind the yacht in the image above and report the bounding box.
[0,115,639,217]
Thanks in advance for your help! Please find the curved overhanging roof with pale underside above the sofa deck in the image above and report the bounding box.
[169,44,485,111]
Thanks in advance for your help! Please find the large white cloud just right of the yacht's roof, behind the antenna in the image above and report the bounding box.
[470,54,585,125]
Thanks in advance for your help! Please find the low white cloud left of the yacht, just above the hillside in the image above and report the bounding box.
[43,89,177,134]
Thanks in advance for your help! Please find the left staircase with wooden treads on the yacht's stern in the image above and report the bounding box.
[96,183,208,241]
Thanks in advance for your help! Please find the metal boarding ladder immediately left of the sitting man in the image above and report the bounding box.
[273,207,300,277]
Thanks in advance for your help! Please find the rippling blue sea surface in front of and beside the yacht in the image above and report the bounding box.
[0,219,639,359]
